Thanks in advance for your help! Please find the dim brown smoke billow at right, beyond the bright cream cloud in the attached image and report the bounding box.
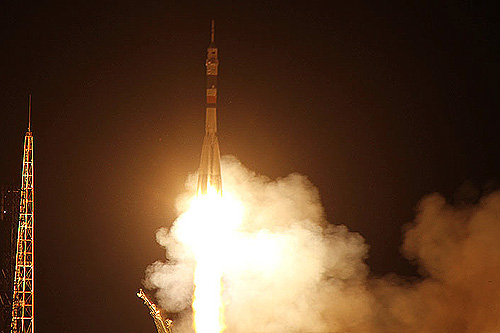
[374,192,500,332]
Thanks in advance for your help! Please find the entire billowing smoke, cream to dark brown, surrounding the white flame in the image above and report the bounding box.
[145,157,500,332]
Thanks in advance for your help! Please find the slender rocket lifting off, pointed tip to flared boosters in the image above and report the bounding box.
[197,20,222,195]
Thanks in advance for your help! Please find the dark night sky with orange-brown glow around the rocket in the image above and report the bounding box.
[0,0,500,332]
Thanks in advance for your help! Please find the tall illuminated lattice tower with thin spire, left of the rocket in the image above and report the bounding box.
[11,94,35,333]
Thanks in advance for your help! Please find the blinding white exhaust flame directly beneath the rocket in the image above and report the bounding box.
[177,188,243,333]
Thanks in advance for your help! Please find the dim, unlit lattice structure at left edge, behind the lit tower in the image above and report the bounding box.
[0,185,19,333]
